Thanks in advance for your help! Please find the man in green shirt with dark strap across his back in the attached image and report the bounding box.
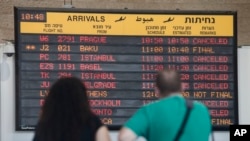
[118,69,211,141]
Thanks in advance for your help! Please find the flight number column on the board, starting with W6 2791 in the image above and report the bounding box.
[39,35,75,106]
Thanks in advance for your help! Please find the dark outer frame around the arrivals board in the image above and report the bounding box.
[14,7,239,131]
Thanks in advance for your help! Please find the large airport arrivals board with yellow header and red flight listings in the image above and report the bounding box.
[15,8,238,130]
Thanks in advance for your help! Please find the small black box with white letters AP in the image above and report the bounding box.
[230,125,250,141]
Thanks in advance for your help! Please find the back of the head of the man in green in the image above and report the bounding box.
[156,69,181,95]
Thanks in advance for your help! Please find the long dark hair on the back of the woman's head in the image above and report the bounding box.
[37,77,92,141]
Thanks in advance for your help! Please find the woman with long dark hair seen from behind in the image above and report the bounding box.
[33,77,110,141]
